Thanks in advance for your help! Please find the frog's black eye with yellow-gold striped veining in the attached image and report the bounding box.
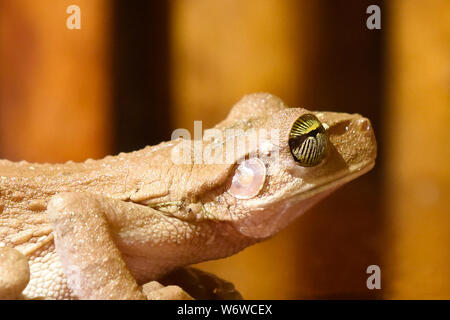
[289,113,328,167]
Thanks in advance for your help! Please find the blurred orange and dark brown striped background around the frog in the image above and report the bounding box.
[0,0,450,299]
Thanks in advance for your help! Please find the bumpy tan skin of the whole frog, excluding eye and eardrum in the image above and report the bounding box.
[0,93,376,299]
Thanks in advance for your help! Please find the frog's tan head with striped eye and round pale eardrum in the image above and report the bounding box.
[211,94,376,239]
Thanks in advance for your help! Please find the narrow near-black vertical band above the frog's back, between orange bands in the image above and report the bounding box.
[112,0,170,152]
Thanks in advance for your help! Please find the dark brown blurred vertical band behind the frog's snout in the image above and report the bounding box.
[297,0,386,298]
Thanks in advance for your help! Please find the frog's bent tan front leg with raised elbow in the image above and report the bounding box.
[47,193,190,299]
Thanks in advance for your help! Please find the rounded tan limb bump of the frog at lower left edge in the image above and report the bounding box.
[0,247,30,299]
